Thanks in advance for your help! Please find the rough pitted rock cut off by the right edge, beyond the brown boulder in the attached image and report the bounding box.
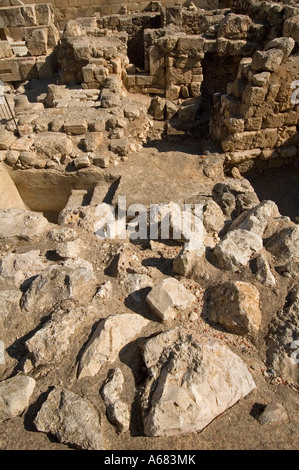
[267,285,299,385]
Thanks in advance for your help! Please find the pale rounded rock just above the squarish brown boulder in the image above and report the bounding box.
[214,229,263,272]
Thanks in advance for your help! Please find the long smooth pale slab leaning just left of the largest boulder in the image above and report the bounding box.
[78,313,149,379]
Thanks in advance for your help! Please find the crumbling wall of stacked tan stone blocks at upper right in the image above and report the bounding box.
[210,38,299,171]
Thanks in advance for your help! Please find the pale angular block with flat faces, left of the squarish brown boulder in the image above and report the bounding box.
[146,277,196,321]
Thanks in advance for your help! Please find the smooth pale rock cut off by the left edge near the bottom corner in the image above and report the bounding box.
[0,375,35,422]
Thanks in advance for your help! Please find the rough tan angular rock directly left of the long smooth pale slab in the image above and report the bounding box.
[26,307,95,367]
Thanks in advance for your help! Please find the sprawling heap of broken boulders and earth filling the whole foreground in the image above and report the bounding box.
[0,173,299,449]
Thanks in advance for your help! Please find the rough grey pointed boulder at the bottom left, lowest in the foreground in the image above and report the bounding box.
[34,387,104,450]
